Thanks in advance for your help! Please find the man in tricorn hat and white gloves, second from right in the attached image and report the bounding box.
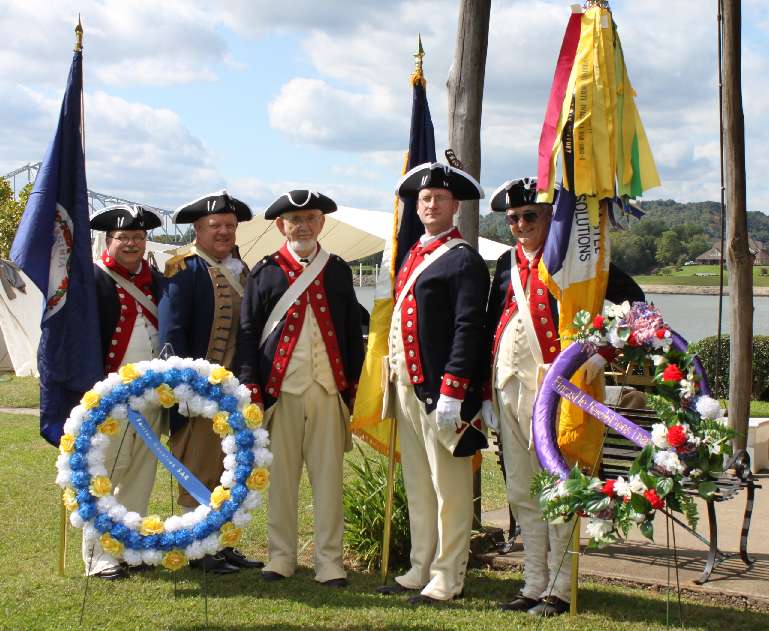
[378,162,489,605]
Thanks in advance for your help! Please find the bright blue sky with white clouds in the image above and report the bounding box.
[0,0,769,217]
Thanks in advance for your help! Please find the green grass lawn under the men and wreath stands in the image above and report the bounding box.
[0,414,766,631]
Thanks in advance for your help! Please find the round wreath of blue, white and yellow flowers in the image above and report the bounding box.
[56,357,272,570]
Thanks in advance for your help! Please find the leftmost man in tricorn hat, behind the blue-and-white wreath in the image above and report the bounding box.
[83,204,163,580]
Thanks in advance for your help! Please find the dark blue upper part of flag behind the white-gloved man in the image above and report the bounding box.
[395,77,435,270]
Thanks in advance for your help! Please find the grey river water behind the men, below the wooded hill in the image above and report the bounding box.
[355,287,769,342]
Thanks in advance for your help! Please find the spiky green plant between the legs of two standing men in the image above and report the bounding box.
[344,443,411,570]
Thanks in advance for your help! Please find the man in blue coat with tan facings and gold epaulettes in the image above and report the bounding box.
[160,191,263,574]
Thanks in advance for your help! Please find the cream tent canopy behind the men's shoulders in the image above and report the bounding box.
[238,206,510,267]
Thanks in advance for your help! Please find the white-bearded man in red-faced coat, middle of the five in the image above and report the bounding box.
[238,190,363,588]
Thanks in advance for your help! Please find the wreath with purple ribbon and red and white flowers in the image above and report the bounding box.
[532,302,734,546]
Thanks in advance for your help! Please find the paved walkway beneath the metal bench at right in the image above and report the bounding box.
[483,471,769,608]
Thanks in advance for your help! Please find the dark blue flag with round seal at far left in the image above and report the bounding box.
[11,51,104,445]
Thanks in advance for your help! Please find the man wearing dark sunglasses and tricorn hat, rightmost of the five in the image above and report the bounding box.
[482,177,644,616]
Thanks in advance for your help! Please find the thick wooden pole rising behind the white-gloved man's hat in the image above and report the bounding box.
[447,0,491,247]
